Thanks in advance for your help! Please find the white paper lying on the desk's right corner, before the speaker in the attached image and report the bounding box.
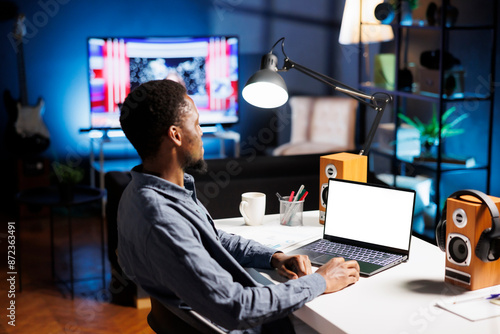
[436,296,500,321]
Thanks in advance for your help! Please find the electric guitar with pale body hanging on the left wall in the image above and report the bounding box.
[4,14,50,156]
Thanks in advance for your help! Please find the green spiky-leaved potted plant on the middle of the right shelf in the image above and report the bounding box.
[398,105,469,156]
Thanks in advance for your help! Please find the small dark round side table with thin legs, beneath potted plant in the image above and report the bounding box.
[17,186,106,299]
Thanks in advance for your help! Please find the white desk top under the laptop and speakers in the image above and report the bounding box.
[215,211,500,334]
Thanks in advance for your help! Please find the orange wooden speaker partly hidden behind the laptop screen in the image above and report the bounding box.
[319,153,368,224]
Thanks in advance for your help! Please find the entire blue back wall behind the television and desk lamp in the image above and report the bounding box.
[0,0,500,196]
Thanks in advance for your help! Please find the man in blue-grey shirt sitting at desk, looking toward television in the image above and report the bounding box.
[118,80,359,333]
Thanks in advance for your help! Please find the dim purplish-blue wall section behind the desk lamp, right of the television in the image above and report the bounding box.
[210,0,343,154]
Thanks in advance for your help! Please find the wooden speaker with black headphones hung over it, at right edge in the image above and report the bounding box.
[445,195,500,290]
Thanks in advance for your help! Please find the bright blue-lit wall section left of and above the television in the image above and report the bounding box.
[0,0,210,159]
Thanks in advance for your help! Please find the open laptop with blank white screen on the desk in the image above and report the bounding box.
[289,179,415,276]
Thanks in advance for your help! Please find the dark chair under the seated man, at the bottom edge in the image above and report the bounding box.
[148,297,225,334]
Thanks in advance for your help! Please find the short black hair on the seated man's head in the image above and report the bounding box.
[120,80,188,161]
